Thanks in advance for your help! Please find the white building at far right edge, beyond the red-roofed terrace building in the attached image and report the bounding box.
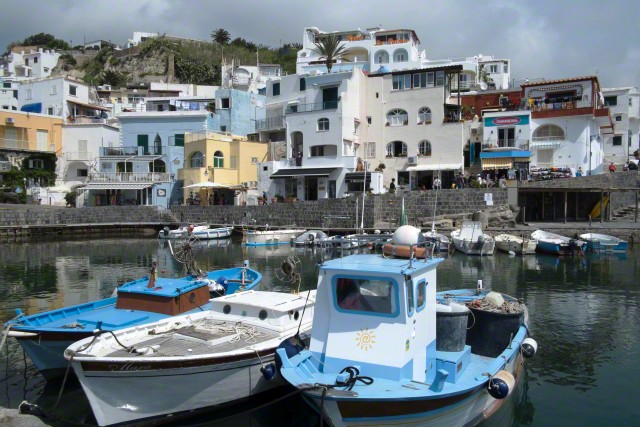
[602,87,640,166]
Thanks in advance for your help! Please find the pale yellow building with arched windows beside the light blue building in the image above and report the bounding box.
[178,132,269,205]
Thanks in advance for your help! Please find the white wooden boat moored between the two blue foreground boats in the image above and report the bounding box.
[65,290,316,426]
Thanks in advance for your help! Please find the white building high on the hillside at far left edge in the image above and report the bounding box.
[0,48,60,81]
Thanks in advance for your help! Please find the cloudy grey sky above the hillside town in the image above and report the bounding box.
[0,0,640,87]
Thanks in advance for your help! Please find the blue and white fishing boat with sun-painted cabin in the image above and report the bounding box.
[277,239,537,426]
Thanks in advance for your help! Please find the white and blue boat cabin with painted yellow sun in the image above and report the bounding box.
[310,255,444,383]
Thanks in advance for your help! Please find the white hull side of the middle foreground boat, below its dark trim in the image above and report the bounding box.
[73,357,284,426]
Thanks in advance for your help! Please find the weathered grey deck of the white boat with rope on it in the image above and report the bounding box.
[104,320,279,358]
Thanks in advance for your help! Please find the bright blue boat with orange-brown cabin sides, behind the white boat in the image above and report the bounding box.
[3,263,262,379]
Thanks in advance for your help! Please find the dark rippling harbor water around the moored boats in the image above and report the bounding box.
[0,239,640,426]
